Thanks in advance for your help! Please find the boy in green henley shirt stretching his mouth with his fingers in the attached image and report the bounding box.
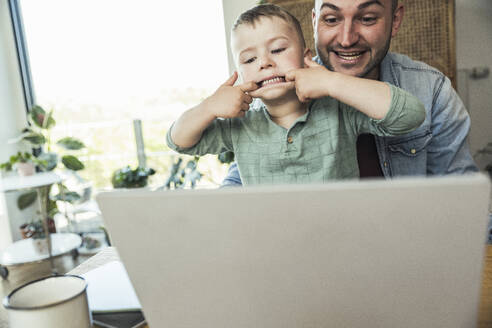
[167,5,425,185]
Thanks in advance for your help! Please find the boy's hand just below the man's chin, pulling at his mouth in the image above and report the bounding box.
[285,57,333,102]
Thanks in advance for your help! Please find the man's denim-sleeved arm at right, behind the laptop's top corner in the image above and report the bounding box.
[427,77,478,175]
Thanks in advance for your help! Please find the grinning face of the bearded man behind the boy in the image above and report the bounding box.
[313,0,403,79]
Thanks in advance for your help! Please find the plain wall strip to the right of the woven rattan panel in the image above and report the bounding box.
[456,0,492,168]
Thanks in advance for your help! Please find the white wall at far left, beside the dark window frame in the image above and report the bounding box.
[0,0,31,251]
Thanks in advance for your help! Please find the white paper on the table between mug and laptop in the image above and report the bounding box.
[82,261,142,312]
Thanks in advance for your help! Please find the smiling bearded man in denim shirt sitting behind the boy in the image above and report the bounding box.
[223,0,477,185]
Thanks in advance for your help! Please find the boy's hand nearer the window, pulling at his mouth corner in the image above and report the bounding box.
[205,72,258,118]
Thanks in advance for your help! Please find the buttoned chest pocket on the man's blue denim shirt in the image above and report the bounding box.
[388,131,432,176]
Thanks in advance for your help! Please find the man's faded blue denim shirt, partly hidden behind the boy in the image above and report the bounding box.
[222,52,478,186]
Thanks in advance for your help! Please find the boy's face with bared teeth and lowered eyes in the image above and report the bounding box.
[231,17,305,100]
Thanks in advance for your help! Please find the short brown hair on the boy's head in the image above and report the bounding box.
[232,4,306,47]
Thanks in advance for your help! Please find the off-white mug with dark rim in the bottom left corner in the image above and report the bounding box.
[3,275,92,328]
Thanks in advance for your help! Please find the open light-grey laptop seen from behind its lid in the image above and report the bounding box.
[97,175,490,328]
